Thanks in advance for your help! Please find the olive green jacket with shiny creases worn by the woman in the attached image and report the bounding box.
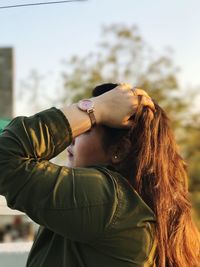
[0,108,156,267]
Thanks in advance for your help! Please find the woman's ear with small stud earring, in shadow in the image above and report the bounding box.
[111,138,131,164]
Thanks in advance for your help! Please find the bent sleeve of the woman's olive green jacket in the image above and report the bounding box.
[0,108,117,242]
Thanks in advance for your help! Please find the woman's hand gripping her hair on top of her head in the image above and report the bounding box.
[92,83,155,128]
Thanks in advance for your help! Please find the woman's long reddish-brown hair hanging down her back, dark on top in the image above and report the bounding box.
[93,84,200,267]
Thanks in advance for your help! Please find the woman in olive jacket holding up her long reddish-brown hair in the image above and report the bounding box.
[0,84,200,267]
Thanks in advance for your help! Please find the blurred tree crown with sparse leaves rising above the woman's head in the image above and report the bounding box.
[62,24,181,113]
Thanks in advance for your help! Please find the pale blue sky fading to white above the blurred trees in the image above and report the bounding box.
[0,0,200,114]
